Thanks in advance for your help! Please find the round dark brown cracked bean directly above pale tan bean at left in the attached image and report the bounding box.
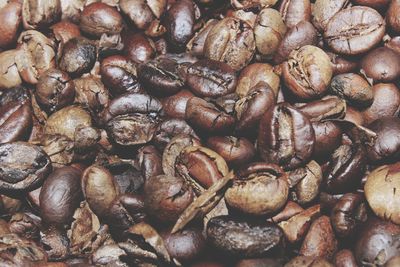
[35,69,75,112]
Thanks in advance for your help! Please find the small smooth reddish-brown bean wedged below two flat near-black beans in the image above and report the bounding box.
[161,89,194,119]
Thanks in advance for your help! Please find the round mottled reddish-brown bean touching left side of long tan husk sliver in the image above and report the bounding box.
[144,175,194,223]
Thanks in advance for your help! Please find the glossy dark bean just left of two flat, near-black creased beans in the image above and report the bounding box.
[100,55,140,96]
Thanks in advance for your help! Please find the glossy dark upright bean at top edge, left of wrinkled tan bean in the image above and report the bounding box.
[165,0,196,50]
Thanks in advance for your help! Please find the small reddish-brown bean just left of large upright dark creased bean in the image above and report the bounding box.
[207,136,256,167]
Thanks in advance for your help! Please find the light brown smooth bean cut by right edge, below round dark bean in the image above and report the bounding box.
[362,83,400,125]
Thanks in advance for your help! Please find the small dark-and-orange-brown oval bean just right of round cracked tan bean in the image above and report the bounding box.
[330,73,374,107]
